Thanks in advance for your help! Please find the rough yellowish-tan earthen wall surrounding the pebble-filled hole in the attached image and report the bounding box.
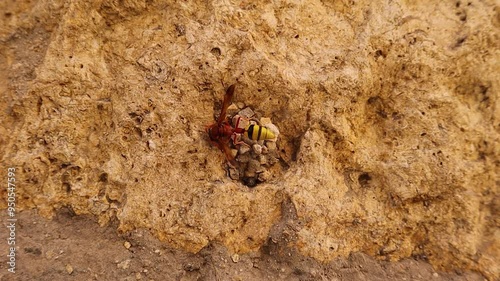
[0,0,500,278]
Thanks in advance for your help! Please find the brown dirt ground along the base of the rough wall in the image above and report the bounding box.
[0,203,485,281]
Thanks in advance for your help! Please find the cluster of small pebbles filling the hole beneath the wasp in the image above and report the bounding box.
[228,107,279,187]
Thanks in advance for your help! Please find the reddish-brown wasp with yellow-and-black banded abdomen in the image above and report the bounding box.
[207,84,275,167]
